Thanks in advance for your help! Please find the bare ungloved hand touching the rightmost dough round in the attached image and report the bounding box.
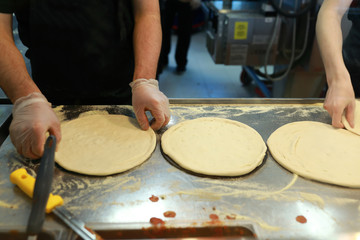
[324,82,355,128]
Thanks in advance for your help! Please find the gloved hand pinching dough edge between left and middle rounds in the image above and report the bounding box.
[130,78,170,130]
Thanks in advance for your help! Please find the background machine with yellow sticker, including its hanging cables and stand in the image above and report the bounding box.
[205,0,325,98]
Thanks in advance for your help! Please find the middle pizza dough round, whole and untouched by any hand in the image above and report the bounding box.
[161,118,266,176]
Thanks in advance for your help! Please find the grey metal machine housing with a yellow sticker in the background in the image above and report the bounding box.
[206,1,280,66]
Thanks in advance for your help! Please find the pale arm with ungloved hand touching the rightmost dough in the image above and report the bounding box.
[316,0,355,128]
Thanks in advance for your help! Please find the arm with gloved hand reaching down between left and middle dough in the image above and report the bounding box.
[130,0,170,130]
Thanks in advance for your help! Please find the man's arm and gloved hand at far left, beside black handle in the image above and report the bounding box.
[0,13,61,159]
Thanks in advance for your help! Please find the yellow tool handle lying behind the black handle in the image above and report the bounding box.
[10,168,64,213]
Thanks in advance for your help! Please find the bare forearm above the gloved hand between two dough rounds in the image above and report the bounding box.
[134,0,162,79]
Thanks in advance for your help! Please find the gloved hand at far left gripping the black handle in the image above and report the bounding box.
[10,92,61,159]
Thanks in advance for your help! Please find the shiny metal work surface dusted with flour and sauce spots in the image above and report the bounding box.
[0,99,360,239]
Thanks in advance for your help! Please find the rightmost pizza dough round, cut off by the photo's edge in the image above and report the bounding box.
[267,121,360,188]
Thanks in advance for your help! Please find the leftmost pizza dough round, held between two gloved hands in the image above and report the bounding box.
[55,115,156,176]
